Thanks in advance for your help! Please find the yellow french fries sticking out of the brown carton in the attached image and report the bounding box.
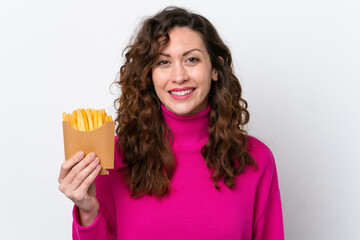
[63,108,112,132]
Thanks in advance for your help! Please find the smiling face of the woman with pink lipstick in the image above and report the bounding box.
[152,27,218,116]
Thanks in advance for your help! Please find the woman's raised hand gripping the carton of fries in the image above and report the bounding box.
[58,152,101,226]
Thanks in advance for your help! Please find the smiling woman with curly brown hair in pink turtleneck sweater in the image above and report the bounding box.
[59,7,284,239]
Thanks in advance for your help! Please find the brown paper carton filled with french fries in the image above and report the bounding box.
[63,108,115,175]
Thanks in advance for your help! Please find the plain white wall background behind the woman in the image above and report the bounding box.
[0,0,360,240]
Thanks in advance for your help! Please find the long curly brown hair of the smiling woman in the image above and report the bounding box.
[114,7,256,197]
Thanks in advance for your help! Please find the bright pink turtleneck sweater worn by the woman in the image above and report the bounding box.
[73,106,284,240]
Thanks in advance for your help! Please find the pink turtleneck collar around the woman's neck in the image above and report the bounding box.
[161,104,210,148]
